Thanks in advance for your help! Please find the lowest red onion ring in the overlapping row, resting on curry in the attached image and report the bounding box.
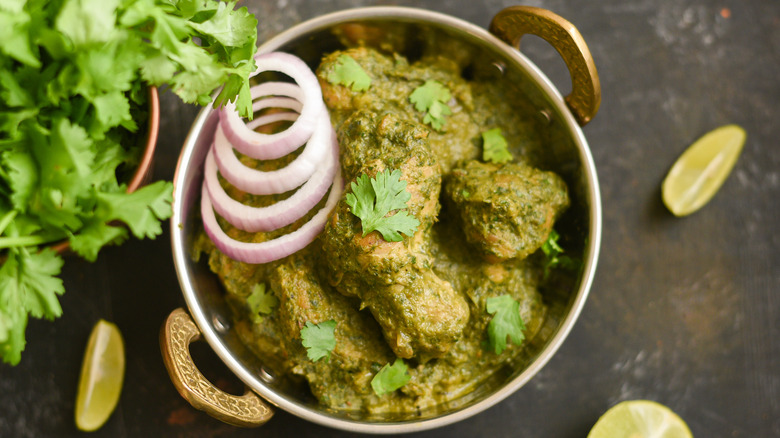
[200,172,343,264]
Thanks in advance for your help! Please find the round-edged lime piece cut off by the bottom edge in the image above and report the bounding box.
[588,400,693,438]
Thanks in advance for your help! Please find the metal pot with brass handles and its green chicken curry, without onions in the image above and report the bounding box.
[161,7,601,433]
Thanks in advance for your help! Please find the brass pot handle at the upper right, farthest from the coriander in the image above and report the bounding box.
[490,6,601,126]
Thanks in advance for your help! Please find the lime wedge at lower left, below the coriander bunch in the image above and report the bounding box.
[76,319,125,432]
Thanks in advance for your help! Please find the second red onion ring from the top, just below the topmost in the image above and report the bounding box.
[214,111,333,195]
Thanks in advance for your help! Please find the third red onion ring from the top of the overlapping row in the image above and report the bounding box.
[204,128,339,232]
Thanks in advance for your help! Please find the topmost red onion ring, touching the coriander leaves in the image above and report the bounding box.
[220,52,325,160]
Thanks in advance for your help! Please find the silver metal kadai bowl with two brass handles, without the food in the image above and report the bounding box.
[160,6,601,433]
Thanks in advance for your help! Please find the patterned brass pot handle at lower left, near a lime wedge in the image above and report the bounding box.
[160,309,274,427]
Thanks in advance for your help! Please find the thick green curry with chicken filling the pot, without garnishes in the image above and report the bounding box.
[198,48,569,415]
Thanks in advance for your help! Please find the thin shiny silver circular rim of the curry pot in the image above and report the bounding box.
[170,6,602,434]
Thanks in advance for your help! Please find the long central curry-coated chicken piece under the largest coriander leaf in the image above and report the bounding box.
[322,111,469,361]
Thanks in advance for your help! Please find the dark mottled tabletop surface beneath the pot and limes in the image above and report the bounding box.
[0,0,780,438]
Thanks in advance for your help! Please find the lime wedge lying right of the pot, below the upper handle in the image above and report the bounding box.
[661,125,747,216]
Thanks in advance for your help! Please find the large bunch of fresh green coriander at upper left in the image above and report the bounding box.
[0,0,257,365]
